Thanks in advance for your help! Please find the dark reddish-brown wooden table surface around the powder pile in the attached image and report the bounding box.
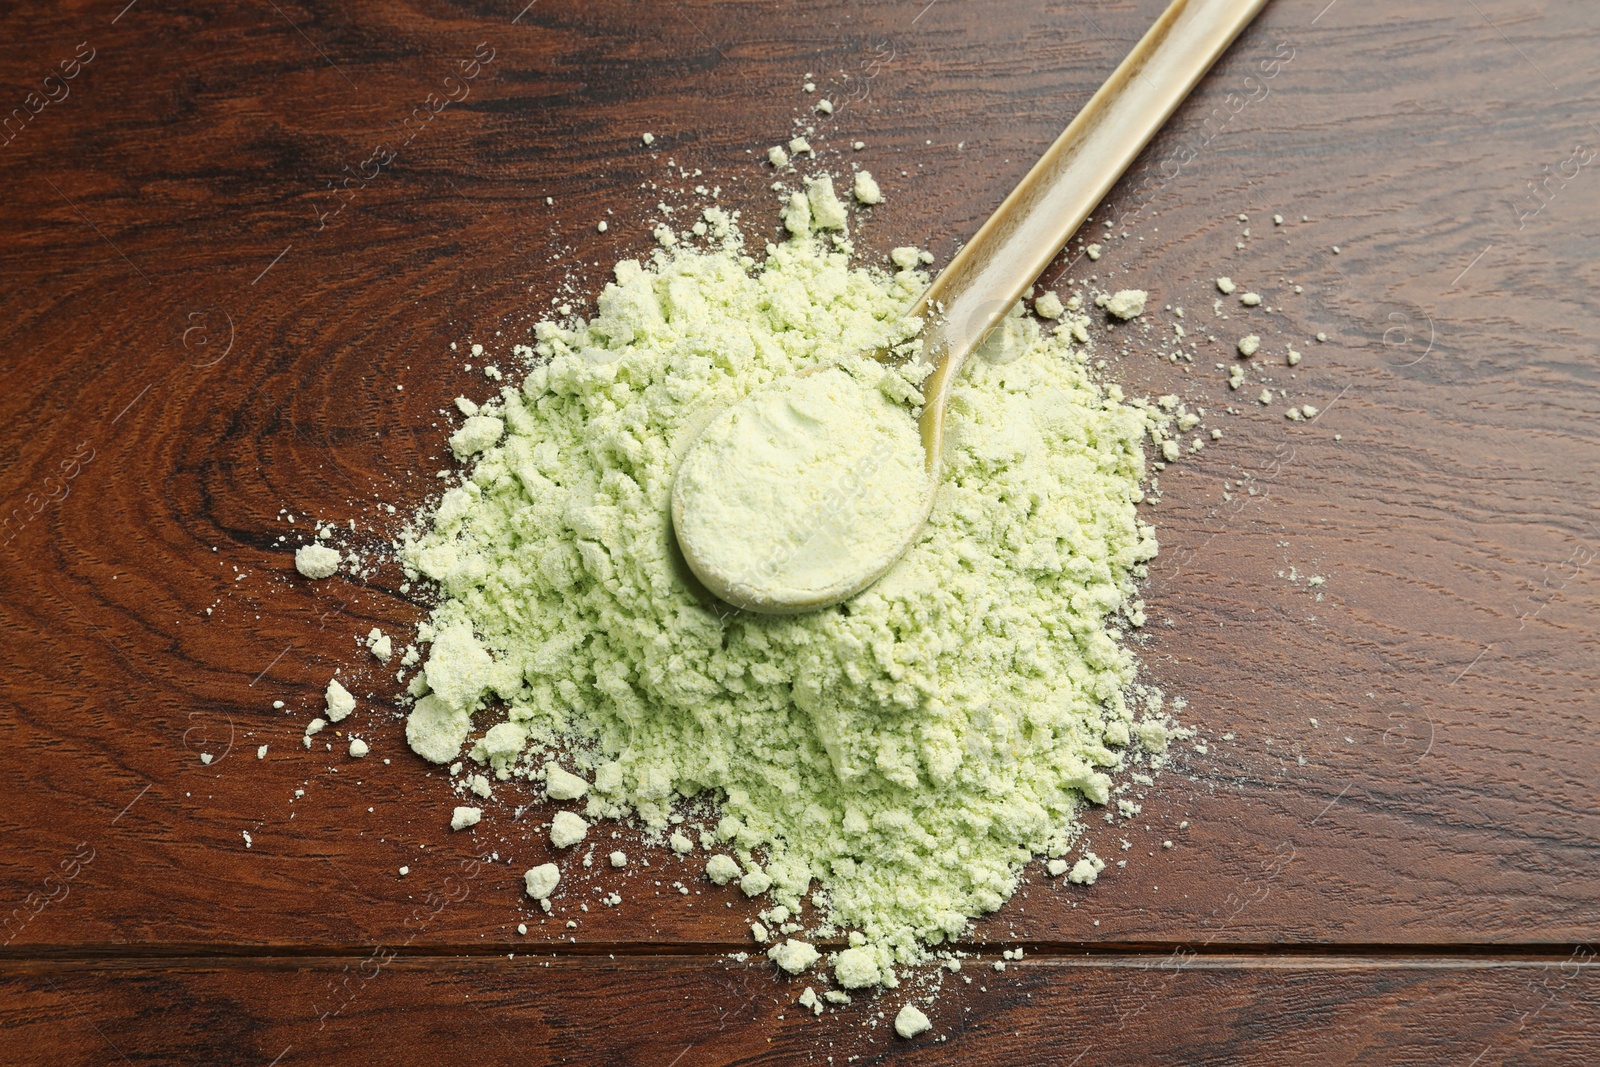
[0,0,1600,1067]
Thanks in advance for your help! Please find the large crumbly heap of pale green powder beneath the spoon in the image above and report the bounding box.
[403,186,1177,985]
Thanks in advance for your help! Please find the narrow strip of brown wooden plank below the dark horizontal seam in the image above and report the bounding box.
[0,955,1600,1067]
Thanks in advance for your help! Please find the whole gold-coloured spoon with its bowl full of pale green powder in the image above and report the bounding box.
[672,0,1267,614]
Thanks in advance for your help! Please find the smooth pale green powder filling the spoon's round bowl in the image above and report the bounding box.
[672,361,930,608]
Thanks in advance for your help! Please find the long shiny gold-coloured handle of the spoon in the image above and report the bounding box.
[909,0,1267,469]
